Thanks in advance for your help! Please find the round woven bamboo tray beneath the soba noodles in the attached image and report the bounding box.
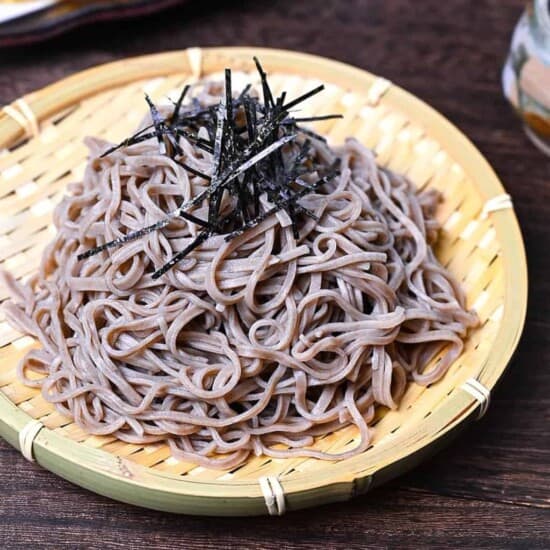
[0,48,527,515]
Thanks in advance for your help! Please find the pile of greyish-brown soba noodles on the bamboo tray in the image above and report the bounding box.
[3,85,477,468]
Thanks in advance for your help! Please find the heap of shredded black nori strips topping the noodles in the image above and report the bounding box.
[78,57,341,279]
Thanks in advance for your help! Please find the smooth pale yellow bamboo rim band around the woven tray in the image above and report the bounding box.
[0,47,527,513]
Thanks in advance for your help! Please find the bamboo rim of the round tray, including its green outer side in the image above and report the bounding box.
[0,48,527,515]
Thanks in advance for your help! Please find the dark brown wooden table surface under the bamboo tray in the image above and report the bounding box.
[0,0,550,549]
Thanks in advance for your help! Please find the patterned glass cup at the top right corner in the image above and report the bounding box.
[502,0,550,155]
